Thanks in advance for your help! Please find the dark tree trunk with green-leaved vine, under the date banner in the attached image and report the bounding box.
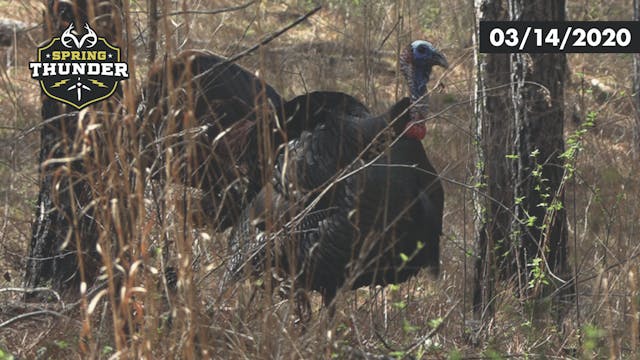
[508,0,568,295]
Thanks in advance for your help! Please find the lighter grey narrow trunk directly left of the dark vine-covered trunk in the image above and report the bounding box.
[473,0,513,315]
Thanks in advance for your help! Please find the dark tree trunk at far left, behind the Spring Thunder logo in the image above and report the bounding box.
[24,0,122,293]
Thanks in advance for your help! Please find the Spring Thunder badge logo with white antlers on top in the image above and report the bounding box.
[29,23,129,110]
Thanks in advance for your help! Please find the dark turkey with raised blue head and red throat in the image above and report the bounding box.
[226,41,448,304]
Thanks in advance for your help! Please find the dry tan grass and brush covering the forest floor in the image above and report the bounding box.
[0,0,640,359]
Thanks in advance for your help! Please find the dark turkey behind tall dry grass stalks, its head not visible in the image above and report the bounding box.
[139,50,283,230]
